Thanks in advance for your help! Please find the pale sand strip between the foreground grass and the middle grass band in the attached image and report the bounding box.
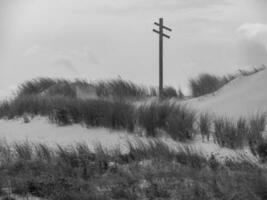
[0,117,256,162]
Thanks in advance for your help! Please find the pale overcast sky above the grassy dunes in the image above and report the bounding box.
[0,0,267,90]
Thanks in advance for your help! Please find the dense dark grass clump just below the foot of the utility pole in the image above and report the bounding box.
[137,101,195,141]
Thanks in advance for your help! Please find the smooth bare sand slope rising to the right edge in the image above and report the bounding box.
[186,69,267,118]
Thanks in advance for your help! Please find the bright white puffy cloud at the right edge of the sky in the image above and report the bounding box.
[240,23,267,38]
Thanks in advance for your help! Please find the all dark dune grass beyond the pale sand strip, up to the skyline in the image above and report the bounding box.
[0,68,266,150]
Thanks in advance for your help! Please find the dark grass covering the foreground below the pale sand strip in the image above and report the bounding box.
[0,140,267,200]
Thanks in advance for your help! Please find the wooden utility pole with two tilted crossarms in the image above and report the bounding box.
[153,18,172,97]
